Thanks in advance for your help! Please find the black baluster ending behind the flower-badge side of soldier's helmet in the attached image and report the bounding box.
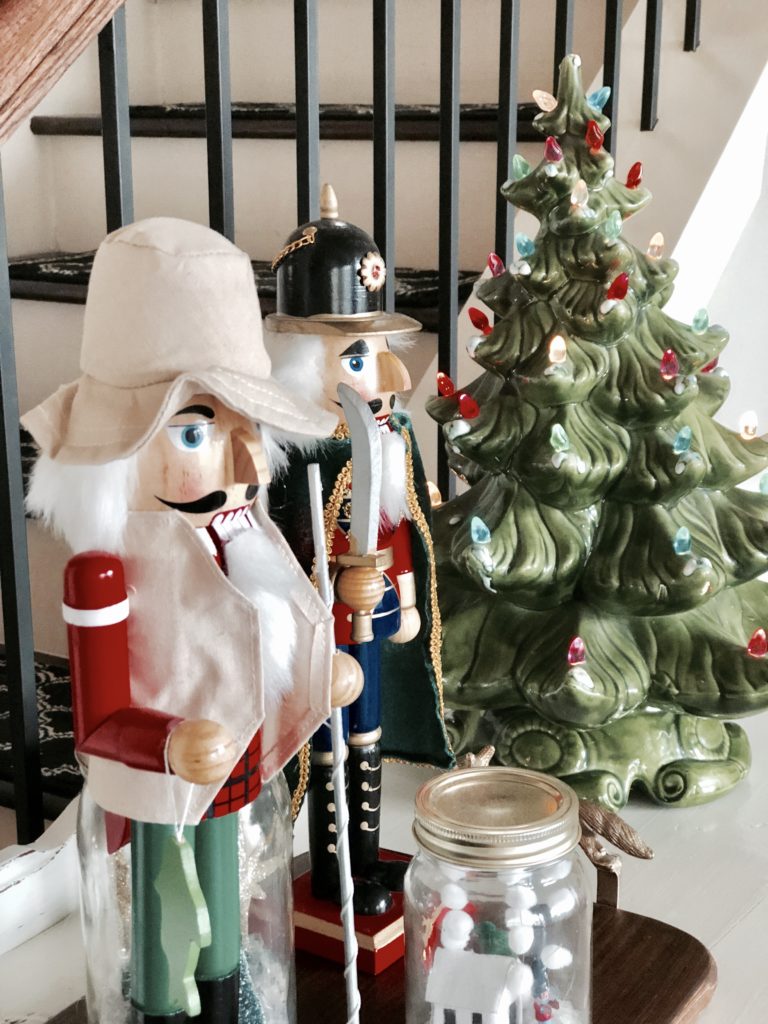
[373,0,394,310]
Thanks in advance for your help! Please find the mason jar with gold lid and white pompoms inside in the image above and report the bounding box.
[404,768,592,1024]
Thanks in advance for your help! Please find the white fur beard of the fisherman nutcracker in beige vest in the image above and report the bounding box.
[224,526,296,714]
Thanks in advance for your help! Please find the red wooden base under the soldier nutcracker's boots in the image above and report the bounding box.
[293,850,411,975]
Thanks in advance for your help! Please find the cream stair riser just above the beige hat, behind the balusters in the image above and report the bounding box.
[40,136,542,269]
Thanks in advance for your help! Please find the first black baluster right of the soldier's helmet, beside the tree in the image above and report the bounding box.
[437,0,461,499]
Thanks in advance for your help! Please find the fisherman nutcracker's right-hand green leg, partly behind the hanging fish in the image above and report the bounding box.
[195,814,241,1024]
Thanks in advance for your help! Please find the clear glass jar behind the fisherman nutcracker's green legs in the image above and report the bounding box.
[78,772,296,1024]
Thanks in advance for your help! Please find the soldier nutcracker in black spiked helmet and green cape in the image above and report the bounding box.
[266,185,453,913]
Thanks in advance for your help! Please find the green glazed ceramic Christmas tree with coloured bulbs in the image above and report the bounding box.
[428,56,768,808]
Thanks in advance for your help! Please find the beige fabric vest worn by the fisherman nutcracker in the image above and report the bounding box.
[84,503,335,824]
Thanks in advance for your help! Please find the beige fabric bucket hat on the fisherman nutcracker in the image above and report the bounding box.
[22,217,337,464]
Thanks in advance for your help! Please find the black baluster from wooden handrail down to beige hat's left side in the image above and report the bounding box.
[98,7,133,231]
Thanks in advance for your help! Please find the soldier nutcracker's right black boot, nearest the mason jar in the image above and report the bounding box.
[349,729,408,893]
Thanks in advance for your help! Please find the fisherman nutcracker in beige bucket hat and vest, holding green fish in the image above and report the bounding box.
[24,218,354,1024]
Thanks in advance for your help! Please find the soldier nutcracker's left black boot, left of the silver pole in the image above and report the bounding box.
[308,751,392,915]
